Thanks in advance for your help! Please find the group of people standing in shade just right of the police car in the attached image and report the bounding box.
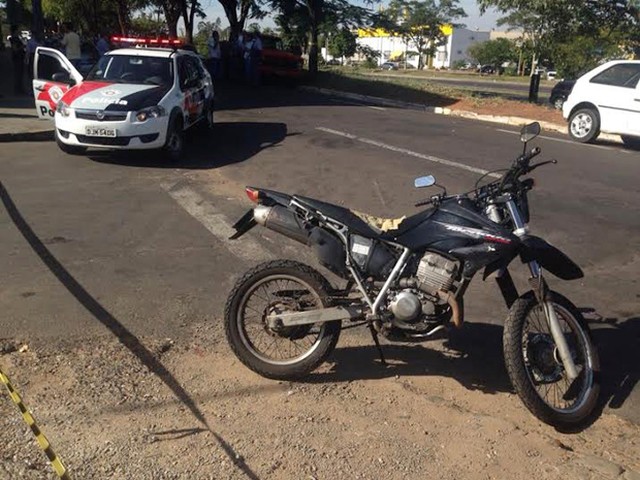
[207,30,262,86]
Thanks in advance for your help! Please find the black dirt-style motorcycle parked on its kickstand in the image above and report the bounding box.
[225,123,599,425]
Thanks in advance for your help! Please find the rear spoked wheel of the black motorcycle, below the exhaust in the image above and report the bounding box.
[225,260,340,380]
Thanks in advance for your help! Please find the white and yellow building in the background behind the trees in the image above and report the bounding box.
[357,26,490,68]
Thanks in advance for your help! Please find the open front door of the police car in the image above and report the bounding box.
[33,47,82,120]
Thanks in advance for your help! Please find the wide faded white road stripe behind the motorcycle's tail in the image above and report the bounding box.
[162,183,274,262]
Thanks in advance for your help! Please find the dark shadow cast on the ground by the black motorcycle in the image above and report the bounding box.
[306,317,640,433]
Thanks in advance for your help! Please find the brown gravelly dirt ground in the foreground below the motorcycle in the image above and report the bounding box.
[0,322,640,480]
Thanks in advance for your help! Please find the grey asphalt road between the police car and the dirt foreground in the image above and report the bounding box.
[0,87,640,422]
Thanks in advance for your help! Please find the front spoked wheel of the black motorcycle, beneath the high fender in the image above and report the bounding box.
[503,292,600,426]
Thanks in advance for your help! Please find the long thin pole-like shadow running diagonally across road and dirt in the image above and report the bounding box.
[0,182,258,480]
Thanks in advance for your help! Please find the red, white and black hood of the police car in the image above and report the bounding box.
[62,81,171,111]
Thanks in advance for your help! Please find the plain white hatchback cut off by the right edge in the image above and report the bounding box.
[562,60,640,148]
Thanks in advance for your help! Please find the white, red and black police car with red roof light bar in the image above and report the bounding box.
[33,37,214,160]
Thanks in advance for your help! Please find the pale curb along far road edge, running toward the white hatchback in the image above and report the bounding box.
[299,85,622,143]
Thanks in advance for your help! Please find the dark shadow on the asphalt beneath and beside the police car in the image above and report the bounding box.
[88,122,288,170]
